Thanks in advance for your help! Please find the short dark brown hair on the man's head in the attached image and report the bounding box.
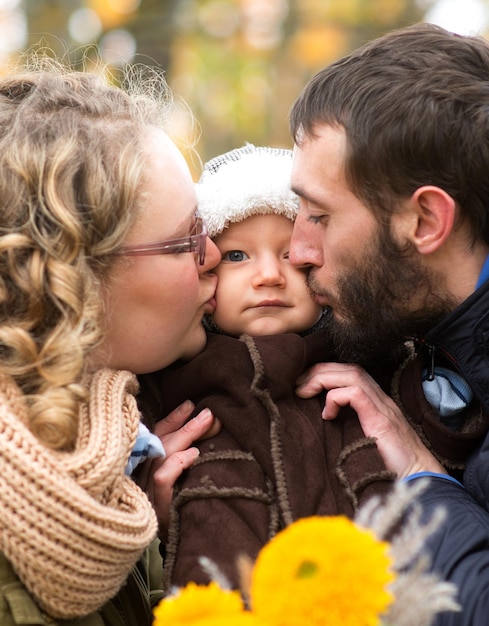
[290,24,489,243]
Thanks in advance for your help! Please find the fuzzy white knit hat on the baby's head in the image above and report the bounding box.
[196,143,299,237]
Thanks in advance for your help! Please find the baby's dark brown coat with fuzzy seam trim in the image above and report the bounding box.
[142,332,392,587]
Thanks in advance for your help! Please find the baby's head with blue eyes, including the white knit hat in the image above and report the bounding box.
[197,145,322,337]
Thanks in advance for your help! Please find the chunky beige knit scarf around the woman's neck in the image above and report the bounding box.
[0,369,157,619]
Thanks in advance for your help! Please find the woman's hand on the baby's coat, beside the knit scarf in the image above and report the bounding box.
[146,400,221,538]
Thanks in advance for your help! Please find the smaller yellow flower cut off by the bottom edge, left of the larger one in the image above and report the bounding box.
[153,582,264,626]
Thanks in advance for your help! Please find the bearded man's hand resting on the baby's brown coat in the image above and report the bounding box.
[296,363,446,478]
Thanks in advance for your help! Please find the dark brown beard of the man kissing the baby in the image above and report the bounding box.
[307,226,457,364]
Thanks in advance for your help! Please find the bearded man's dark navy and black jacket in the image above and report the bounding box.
[392,281,489,626]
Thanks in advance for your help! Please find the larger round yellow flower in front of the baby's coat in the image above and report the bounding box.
[251,516,394,626]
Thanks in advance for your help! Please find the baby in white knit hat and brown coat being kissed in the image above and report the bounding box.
[137,145,393,588]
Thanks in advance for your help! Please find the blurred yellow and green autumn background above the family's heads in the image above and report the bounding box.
[5,0,489,177]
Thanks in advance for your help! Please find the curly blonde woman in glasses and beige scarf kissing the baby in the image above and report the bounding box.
[0,57,219,626]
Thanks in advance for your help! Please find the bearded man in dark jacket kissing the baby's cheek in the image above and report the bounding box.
[290,24,489,626]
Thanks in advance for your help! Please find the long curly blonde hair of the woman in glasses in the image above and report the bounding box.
[0,59,171,450]
